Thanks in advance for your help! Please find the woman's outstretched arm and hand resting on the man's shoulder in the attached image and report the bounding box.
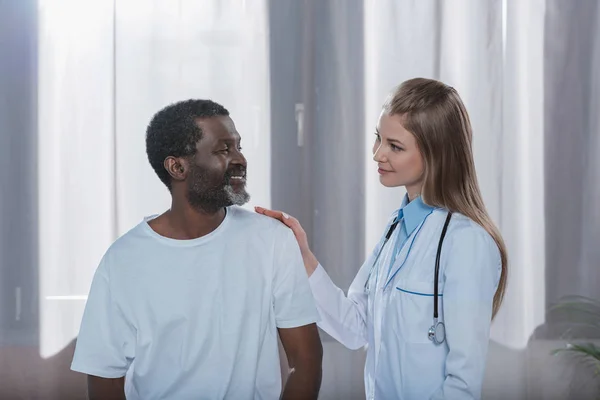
[255,207,368,349]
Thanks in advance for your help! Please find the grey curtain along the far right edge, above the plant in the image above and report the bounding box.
[544,0,600,301]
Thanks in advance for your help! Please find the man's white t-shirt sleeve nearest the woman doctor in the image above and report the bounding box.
[273,229,319,328]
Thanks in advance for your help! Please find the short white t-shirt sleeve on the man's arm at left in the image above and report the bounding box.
[71,259,136,378]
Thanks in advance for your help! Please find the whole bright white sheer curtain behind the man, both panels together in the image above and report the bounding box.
[38,0,270,357]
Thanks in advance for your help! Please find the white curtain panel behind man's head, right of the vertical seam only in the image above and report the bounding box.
[115,0,270,234]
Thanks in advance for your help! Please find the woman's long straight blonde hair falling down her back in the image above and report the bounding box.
[383,78,508,318]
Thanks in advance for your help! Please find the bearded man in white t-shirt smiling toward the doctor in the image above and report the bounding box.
[71,100,322,400]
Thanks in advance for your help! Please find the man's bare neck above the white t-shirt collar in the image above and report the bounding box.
[150,201,226,240]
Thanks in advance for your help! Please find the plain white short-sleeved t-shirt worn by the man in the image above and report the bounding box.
[71,207,319,400]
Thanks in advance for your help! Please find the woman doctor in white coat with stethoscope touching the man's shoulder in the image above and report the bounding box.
[256,78,507,400]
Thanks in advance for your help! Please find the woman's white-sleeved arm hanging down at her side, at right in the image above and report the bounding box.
[432,225,501,399]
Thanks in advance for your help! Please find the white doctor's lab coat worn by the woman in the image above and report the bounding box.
[309,209,501,400]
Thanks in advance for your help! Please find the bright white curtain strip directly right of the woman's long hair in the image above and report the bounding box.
[496,0,546,349]
